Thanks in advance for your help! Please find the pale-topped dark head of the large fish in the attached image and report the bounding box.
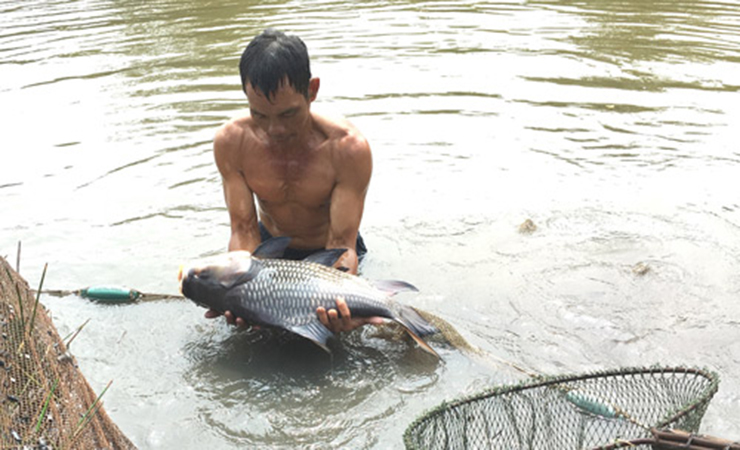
[178,251,259,312]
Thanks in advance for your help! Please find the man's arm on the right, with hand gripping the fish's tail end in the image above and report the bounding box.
[316,135,382,333]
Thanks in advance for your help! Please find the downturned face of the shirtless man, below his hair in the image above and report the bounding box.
[246,79,318,145]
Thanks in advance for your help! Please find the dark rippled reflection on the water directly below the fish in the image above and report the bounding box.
[185,330,437,446]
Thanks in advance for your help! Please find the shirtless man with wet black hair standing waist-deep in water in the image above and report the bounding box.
[206,29,380,333]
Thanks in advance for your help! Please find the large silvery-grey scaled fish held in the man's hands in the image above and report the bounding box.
[179,237,438,356]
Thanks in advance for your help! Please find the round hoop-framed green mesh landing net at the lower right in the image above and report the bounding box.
[404,368,719,450]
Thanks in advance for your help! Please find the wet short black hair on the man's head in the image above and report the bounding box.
[239,28,311,99]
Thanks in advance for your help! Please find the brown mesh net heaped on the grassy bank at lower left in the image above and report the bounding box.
[0,257,135,450]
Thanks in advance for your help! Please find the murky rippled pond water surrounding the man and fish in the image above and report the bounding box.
[0,0,740,449]
